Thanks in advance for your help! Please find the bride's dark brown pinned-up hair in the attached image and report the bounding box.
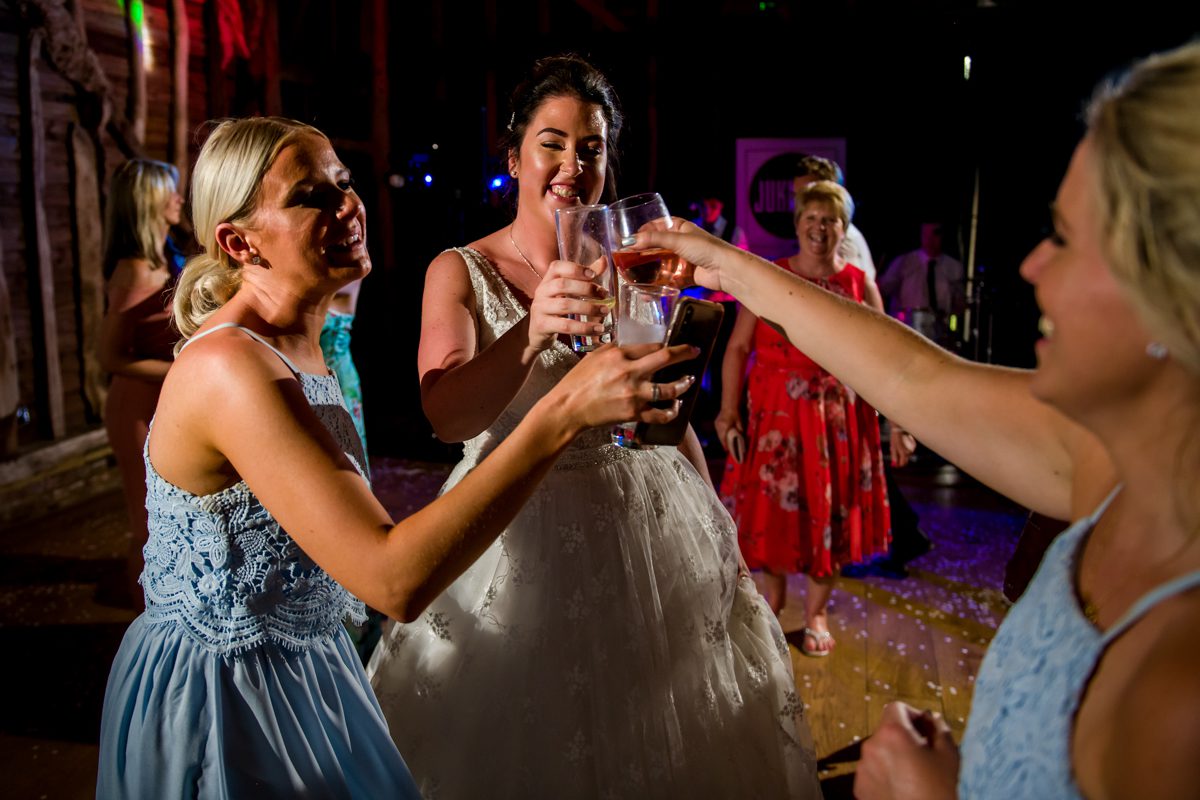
[499,53,624,203]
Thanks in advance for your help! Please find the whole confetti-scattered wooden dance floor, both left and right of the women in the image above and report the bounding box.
[0,458,1025,800]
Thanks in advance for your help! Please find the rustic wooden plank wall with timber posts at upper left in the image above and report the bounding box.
[0,0,209,457]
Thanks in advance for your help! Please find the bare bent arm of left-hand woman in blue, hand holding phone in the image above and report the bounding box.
[150,333,695,620]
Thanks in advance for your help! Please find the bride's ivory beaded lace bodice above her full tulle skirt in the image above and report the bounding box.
[454,247,636,470]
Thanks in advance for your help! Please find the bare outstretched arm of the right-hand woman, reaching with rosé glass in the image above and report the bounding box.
[637,221,1098,518]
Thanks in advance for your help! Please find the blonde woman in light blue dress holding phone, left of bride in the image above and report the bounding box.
[96,118,691,799]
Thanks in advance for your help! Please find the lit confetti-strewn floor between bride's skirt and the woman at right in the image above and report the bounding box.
[780,471,1026,800]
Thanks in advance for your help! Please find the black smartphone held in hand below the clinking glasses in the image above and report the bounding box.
[634,297,725,445]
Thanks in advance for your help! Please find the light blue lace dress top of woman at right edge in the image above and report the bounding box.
[959,492,1200,800]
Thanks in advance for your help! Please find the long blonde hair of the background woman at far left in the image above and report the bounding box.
[104,158,179,278]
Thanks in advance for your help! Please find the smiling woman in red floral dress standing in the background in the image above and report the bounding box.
[716,181,890,656]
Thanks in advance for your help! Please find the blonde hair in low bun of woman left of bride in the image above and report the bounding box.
[174,116,326,350]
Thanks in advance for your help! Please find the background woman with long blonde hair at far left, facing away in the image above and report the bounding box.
[97,158,184,608]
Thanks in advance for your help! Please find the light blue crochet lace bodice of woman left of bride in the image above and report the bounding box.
[142,326,366,655]
